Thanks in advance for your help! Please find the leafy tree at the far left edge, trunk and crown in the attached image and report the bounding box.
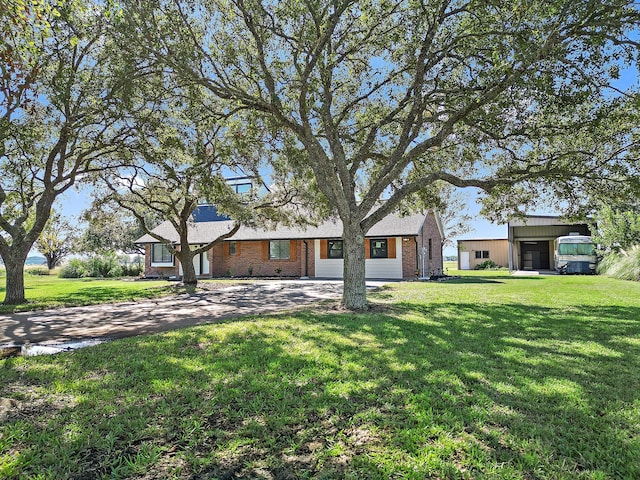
[0,1,135,304]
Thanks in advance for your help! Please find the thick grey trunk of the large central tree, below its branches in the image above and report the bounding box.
[342,222,367,310]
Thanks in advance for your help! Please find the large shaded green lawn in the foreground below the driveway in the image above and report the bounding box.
[0,272,640,479]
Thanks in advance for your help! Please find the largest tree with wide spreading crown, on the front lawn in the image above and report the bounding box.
[119,0,640,310]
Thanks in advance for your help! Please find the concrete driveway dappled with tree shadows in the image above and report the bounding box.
[0,280,385,345]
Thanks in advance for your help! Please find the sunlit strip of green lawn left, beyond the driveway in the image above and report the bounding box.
[0,272,173,313]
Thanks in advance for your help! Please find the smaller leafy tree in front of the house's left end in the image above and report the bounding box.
[98,57,310,288]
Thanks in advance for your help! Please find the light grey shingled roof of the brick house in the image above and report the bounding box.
[135,213,442,244]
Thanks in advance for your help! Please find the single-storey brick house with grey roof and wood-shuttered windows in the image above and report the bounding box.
[136,212,443,279]
